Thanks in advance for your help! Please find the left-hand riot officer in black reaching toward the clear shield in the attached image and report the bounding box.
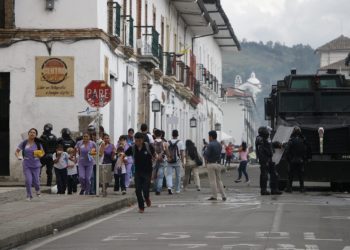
[255,127,282,195]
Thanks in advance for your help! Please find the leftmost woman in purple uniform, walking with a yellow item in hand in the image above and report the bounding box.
[15,128,45,201]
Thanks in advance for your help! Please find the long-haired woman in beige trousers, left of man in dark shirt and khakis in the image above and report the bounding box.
[183,140,201,191]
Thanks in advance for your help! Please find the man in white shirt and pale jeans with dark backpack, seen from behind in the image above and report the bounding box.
[166,130,185,195]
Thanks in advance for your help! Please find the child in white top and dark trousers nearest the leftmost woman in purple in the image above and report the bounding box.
[52,144,69,194]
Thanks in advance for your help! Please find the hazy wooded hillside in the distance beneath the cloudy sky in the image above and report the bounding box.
[223,41,320,124]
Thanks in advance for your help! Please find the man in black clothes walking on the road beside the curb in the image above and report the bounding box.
[125,132,155,213]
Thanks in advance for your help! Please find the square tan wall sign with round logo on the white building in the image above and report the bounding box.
[35,56,74,97]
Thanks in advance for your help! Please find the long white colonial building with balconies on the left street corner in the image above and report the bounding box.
[0,0,240,181]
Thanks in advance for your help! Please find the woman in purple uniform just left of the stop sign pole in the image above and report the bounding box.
[75,133,96,195]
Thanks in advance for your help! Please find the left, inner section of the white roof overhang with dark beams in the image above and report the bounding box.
[171,0,218,36]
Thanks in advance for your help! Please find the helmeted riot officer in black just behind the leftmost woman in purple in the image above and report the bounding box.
[40,123,57,187]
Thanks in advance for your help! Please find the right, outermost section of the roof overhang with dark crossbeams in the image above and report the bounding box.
[203,0,241,51]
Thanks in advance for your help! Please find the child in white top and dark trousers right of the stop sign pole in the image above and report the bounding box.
[114,146,128,195]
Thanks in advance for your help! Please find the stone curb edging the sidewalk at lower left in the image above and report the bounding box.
[0,197,136,250]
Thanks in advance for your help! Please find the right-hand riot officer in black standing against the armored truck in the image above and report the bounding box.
[285,127,308,193]
